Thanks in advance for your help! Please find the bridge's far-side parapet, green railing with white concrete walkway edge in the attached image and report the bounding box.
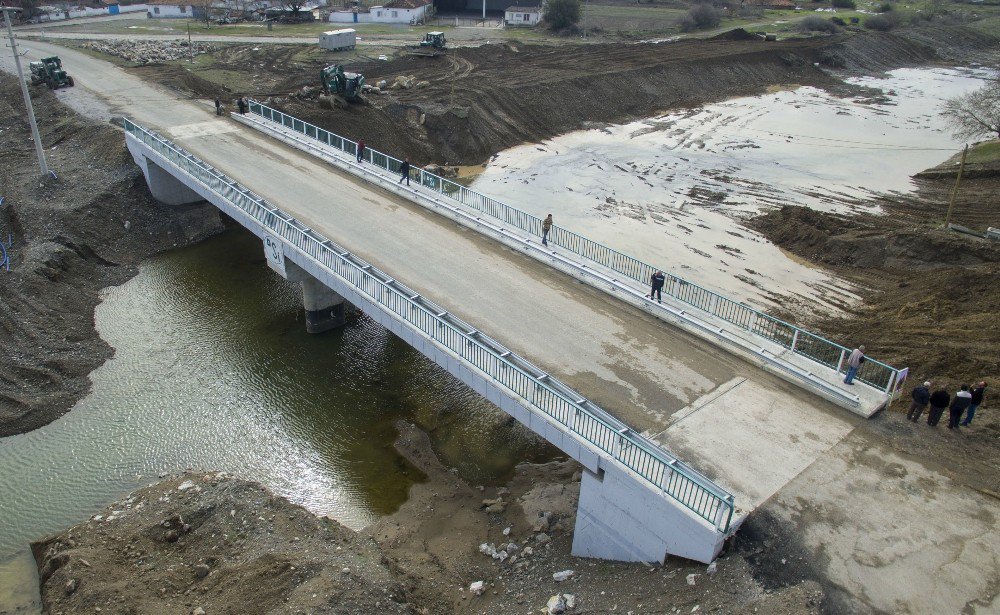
[244,101,901,416]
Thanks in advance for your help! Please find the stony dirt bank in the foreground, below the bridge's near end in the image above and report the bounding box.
[33,424,823,615]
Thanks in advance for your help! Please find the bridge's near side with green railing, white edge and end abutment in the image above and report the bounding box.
[124,119,742,561]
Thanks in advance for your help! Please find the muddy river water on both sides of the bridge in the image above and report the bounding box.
[0,63,983,613]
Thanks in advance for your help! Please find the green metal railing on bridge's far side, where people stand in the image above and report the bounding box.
[250,100,899,393]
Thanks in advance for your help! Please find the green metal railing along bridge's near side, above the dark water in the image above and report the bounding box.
[124,119,735,532]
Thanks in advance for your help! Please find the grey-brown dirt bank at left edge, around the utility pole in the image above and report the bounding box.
[0,73,221,437]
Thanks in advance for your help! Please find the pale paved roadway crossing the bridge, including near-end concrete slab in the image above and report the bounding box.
[1,43,856,508]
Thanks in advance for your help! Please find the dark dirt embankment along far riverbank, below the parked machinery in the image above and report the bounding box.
[139,28,997,165]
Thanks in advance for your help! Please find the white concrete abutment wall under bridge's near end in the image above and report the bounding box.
[573,464,725,564]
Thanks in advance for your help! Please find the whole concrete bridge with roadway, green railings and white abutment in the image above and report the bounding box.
[119,103,895,562]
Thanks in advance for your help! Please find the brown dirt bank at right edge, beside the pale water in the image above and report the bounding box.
[751,172,1000,394]
